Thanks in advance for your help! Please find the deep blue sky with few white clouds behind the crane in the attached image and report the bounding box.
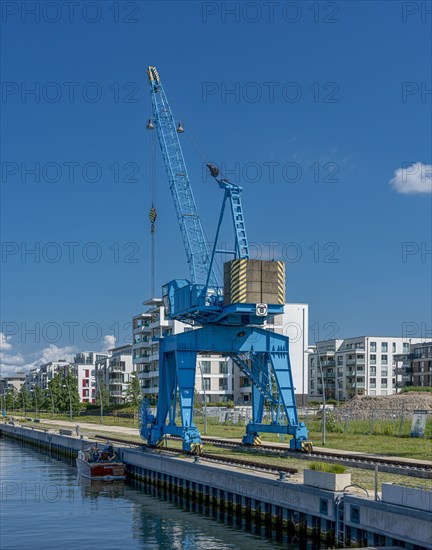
[1,1,432,376]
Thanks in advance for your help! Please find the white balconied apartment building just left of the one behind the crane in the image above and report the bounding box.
[95,344,134,405]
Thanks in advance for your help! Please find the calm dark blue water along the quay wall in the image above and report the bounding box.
[0,438,294,550]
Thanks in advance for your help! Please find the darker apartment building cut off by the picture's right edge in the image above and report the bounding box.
[395,341,432,388]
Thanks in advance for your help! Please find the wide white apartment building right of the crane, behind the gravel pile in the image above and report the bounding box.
[308,336,421,401]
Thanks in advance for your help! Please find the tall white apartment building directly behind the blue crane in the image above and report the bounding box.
[132,298,308,404]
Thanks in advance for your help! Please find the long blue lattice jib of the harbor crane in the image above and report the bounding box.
[147,67,218,287]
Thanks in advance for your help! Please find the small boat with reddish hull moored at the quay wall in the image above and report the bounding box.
[76,445,126,481]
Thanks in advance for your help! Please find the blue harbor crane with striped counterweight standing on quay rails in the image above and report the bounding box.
[140,67,312,453]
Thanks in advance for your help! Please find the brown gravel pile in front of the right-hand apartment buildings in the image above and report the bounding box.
[335,392,432,420]
